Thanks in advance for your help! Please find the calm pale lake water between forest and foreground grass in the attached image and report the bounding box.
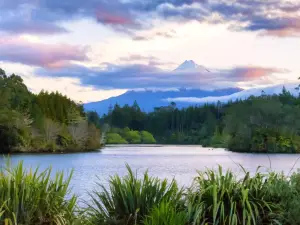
[0,145,300,199]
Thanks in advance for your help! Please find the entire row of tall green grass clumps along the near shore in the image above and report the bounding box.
[0,162,300,225]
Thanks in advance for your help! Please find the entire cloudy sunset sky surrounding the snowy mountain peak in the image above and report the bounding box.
[0,0,300,102]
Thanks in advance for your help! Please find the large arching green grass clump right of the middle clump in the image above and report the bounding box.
[188,167,279,225]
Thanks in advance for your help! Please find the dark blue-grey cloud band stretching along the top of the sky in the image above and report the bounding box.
[0,0,300,37]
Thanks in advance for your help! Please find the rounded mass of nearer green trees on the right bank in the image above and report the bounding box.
[224,95,300,153]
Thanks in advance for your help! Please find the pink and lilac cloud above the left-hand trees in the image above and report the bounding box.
[0,37,87,69]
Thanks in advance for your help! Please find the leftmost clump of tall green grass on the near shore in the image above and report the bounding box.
[0,162,77,225]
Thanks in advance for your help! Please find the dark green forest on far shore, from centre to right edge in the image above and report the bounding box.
[101,89,300,153]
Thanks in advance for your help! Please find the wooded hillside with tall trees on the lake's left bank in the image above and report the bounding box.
[0,69,100,152]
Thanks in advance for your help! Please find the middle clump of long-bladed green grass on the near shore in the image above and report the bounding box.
[88,165,182,225]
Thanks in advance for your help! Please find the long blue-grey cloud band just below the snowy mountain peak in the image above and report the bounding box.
[36,64,287,89]
